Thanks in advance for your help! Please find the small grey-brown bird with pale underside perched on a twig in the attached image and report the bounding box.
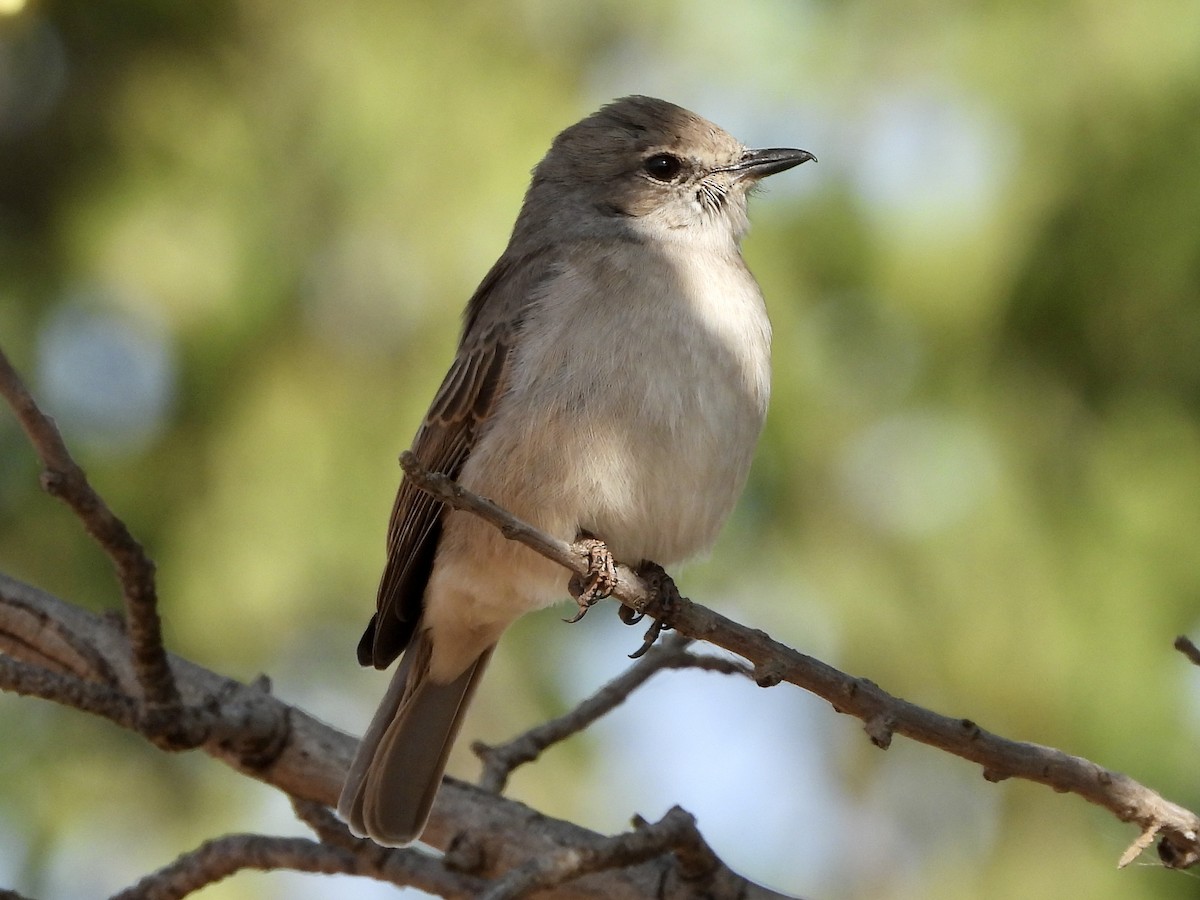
[337,96,816,846]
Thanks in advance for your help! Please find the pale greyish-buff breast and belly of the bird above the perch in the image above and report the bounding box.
[469,236,770,564]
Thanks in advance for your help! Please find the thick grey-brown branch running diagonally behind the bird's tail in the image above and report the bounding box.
[0,574,786,900]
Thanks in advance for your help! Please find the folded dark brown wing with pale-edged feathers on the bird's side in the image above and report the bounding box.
[358,253,550,668]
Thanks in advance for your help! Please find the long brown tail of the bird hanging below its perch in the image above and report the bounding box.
[337,631,494,847]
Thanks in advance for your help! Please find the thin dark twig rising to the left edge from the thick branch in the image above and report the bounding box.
[0,349,181,749]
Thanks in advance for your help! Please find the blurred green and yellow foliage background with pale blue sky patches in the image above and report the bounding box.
[0,0,1200,900]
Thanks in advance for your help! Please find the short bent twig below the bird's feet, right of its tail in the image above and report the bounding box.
[470,635,751,793]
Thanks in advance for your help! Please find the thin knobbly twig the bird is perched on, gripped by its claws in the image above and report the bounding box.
[401,454,1200,869]
